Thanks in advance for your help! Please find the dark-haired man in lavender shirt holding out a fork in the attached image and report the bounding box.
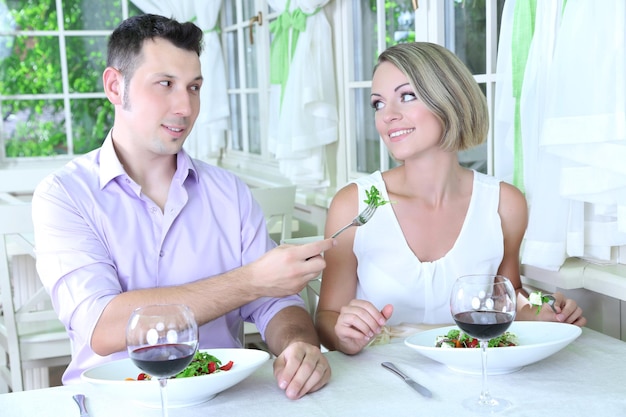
[33,15,334,399]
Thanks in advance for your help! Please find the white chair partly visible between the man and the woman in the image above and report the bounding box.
[242,185,296,350]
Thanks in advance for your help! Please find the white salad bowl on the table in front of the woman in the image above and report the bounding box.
[404,321,582,375]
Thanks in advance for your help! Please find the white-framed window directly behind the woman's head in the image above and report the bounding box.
[342,0,504,182]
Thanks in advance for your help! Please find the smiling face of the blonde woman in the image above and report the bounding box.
[371,62,443,161]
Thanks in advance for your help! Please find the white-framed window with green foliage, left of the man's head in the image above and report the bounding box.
[0,0,141,162]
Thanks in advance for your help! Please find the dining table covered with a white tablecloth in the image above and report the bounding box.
[0,328,626,417]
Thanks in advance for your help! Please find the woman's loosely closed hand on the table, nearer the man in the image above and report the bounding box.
[335,299,393,355]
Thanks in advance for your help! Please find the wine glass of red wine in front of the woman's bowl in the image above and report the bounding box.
[450,274,516,413]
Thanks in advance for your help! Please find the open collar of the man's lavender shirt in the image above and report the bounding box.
[100,129,199,190]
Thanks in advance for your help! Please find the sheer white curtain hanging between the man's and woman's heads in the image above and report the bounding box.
[268,0,338,187]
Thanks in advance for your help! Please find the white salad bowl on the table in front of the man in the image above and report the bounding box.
[81,349,270,408]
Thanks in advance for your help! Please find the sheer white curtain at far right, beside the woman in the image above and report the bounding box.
[495,0,626,270]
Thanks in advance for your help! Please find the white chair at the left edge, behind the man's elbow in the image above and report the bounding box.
[0,203,71,392]
